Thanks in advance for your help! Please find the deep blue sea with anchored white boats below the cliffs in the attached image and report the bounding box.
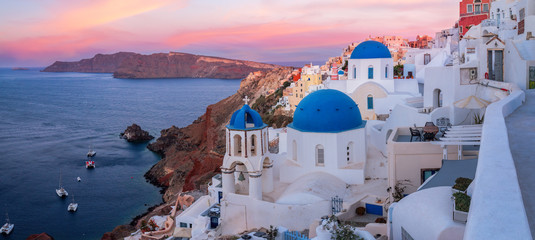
[0,68,240,240]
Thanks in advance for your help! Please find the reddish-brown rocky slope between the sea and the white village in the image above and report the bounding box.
[103,67,293,239]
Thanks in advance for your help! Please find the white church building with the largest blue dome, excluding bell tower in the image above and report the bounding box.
[280,89,366,184]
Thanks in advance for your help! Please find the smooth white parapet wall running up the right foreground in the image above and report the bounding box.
[464,90,532,240]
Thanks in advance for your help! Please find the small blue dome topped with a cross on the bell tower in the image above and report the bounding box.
[227,104,267,130]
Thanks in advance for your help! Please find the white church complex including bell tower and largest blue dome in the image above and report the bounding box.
[216,89,366,234]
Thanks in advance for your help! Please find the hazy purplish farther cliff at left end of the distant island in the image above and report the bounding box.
[43,52,136,73]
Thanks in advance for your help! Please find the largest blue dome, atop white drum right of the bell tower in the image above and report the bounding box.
[288,89,366,132]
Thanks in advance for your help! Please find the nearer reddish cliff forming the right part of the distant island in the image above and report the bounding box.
[113,53,276,79]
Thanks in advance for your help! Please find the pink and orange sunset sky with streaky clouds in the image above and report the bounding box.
[0,0,459,67]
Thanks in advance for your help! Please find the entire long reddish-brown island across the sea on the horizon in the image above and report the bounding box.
[42,52,279,79]
